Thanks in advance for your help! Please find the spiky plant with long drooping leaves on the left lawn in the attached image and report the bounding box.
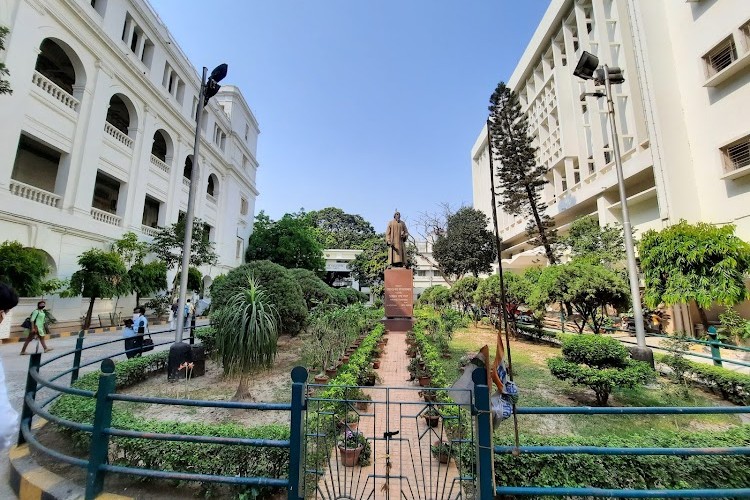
[213,275,279,400]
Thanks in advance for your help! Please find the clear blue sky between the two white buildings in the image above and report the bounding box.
[151,0,549,231]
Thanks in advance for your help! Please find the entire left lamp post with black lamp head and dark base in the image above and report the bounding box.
[168,64,228,378]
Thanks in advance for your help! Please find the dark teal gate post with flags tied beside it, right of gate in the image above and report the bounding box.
[471,368,495,499]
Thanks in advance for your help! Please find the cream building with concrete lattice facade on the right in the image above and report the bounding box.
[471,0,750,327]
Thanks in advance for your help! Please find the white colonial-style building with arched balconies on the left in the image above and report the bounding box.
[0,0,260,326]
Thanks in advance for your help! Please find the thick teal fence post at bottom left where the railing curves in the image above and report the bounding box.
[86,359,115,500]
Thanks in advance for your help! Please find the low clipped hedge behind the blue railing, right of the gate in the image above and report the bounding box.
[494,426,750,489]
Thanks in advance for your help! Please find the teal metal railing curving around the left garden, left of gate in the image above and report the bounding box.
[18,328,307,500]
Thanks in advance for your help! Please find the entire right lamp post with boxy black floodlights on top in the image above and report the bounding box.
[573,51,654,366]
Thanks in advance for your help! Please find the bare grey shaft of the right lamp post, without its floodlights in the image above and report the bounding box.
[603,64,646,348]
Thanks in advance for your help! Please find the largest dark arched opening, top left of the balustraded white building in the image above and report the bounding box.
[34,37,86,98]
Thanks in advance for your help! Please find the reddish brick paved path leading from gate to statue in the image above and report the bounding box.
[315,332,462,500]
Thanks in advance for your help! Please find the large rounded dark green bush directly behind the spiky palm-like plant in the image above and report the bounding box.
[211,260,308,335]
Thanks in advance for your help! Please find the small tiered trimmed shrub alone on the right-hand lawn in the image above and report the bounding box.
[547,334,656,405]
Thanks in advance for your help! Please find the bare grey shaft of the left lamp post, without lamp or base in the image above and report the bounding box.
[175,67,208,342]
